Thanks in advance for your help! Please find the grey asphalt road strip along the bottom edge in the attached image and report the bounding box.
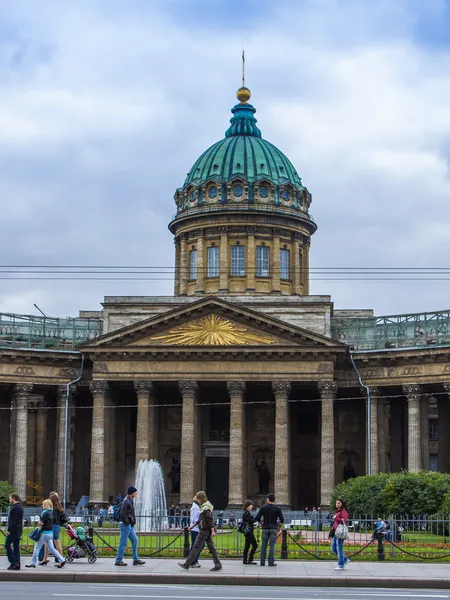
[0,581,450,600]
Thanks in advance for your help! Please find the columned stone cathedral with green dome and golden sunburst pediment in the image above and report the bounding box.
[0,87,450,508]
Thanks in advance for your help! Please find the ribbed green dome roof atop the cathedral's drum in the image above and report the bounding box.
[183,103,303,190]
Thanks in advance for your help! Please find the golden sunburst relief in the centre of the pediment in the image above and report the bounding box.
[150,315,275,346]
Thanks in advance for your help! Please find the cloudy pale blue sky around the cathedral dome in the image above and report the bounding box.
[0,0,450,316]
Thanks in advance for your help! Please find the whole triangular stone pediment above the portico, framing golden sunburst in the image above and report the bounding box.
[82,297,345,352]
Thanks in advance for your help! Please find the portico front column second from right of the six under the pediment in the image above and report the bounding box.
[272,381,291,506]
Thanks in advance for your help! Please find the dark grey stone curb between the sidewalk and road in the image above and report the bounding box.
[0,569,450,590]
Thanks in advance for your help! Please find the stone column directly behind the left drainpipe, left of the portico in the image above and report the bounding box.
[55,385,72,502]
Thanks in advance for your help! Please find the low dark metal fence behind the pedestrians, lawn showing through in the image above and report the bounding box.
[0,511,450,562]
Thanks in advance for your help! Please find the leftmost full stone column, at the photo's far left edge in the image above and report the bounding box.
[13,383,33,500]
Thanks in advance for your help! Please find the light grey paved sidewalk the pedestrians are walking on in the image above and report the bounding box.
[0,556,450,589]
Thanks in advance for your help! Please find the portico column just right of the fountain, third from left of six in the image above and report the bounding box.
[178,381,200,505]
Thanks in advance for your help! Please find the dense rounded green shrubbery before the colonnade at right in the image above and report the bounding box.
[333,471,450,516]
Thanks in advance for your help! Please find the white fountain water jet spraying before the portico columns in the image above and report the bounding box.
[135,460,169,532]
